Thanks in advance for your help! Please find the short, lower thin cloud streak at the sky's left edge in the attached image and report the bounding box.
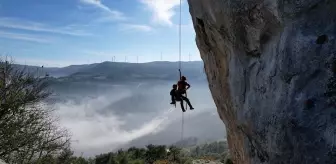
[0,31,51,43]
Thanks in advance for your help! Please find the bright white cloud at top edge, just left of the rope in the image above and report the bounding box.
[140,0,180,26]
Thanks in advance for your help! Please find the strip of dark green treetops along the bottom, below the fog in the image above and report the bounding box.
[32,141,230,164]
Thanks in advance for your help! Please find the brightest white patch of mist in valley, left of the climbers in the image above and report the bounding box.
[55,93,173,155]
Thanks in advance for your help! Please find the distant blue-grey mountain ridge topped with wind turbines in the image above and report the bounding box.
[16,61,205,81]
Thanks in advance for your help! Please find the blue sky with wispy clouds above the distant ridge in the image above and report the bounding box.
[0,0,200,66]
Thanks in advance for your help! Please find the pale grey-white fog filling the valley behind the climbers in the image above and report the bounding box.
[49,81,225,156]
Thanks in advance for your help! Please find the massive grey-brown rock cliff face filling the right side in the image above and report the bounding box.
[188,0,336,164]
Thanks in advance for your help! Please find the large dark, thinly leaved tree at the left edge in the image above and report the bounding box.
[0,61,69,164]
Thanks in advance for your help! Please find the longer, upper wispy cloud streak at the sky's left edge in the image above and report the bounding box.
[0,17,90,36]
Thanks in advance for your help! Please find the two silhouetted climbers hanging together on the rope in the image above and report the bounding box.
[170,76,194,112]
